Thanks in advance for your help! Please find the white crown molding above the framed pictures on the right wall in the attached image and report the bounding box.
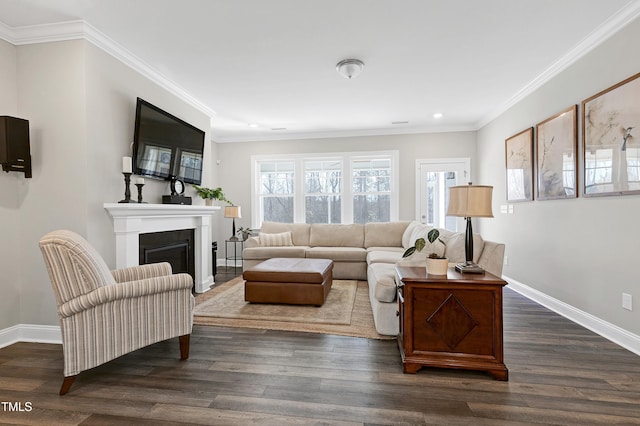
[476,0,640,130]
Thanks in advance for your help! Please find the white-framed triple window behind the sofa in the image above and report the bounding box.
[252,151,398,227]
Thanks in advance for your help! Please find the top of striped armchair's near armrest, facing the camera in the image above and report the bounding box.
[58,274,193,318]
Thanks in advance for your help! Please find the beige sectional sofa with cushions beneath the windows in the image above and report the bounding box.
[243,222,504,335]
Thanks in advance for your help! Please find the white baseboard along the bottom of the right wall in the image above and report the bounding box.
[503,277,640,355]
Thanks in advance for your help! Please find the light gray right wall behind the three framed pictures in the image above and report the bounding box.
[478,15,640,335]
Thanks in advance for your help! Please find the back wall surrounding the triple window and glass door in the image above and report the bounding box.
[214,132,476,246]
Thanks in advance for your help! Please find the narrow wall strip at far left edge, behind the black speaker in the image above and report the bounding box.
[0,40,20,330]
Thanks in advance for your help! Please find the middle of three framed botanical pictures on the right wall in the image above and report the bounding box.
[535,105,578,200]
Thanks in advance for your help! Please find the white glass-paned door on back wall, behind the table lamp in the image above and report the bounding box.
[416,158,471,232]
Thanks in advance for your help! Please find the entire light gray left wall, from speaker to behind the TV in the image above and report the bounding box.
[0,40,215,330]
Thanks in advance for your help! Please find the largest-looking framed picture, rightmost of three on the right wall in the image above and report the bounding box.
[582,73,640,197]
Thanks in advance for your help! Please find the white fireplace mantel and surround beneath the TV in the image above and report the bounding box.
[104,203,220,293]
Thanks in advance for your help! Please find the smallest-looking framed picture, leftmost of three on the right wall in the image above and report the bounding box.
[505,127,533,202]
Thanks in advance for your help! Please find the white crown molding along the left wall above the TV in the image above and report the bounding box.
[0,20,216,117]
